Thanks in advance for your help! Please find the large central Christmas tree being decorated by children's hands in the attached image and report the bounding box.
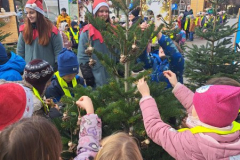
[54,0,184,160]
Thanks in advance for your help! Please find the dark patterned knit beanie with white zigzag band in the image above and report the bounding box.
[23,59,54,95]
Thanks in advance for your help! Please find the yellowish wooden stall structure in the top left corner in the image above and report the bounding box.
[0,0,18,44]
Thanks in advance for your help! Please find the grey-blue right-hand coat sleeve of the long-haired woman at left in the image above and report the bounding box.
[51,32,63,63]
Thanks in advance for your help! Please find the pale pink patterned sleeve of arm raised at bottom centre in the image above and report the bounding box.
[74,114,102,160]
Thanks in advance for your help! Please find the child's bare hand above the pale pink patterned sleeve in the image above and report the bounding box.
[76,96,94,114]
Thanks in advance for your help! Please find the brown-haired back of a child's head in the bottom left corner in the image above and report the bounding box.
[0,116,62,160]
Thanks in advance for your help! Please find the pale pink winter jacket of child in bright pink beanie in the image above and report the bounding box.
[140,83,240,160]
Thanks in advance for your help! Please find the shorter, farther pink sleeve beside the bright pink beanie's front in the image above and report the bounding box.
[172,82,194,113]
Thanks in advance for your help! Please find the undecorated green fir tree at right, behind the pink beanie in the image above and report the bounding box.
[185,0,240,88]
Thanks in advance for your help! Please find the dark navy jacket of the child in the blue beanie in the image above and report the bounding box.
[45,75,84,103]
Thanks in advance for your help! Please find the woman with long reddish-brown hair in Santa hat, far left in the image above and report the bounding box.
[17,0,63,68]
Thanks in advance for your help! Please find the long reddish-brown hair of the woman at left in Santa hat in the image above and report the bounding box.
[23,12,53,46]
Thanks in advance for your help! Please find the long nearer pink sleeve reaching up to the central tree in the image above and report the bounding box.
[140,97,197,159]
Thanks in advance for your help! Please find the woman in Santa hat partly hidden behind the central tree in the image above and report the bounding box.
[78,0,113,87]
